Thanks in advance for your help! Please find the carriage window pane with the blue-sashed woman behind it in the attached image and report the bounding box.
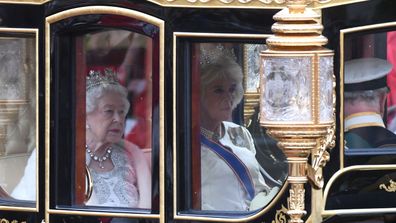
[179,42,287,213]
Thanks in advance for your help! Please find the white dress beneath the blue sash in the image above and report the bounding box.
[201,122,270,211]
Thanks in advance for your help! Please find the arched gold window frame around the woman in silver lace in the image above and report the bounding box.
[45,6,165,222]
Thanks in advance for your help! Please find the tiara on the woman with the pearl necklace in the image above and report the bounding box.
[86,68,119,91]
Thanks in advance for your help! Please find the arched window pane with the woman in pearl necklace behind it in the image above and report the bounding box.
[83,30,152,209]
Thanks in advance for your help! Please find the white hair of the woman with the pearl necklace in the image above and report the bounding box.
[85,84,130,114]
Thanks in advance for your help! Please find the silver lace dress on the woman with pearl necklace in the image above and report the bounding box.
[86,145,139,208]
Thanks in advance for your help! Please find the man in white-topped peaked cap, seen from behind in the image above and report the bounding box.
[344,58,396,148]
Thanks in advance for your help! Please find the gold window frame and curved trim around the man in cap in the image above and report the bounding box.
[321,22,396,217]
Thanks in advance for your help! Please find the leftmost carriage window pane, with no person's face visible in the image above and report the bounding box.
[0,31,38,207]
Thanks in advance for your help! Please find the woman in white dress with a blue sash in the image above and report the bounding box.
[200,57,272,211]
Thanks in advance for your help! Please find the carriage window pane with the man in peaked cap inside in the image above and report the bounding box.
[343,28,396,166]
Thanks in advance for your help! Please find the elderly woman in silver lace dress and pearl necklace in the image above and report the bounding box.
[86,70,151,208]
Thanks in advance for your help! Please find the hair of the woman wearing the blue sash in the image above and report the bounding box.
[200,57,244,109]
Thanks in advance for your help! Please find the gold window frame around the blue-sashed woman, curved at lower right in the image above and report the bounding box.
[172,32,288,222]
